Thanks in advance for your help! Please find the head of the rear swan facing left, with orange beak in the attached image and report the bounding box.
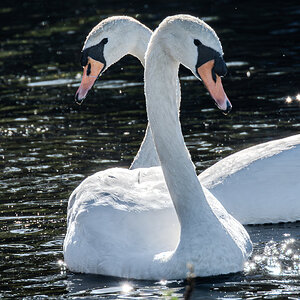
[75,16,152,104]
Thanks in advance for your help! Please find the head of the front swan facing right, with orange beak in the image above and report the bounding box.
[152,15,232,113]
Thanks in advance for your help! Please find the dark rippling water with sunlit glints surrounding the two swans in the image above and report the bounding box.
[0,0,300,299]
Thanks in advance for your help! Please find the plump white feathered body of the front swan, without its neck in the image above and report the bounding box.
[64,167,250,279]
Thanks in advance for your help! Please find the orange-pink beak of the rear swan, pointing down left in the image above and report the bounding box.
[75,57,104,104]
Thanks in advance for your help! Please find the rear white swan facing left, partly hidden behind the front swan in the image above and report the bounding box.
[76,16,300,224]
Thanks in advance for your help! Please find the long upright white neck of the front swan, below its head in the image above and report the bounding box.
[145,43,210,227]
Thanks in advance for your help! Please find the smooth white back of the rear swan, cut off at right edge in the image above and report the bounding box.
[199,135,300,224]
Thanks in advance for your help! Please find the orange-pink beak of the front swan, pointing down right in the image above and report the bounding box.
[197,60,232,114]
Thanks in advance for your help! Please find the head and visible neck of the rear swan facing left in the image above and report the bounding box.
[75,16,161,169]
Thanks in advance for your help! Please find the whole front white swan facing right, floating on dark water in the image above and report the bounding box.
[64,15,252,279]
